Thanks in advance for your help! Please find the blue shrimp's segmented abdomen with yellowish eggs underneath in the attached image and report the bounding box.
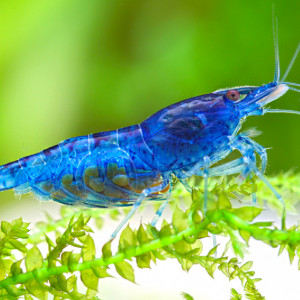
[3,125,168,207]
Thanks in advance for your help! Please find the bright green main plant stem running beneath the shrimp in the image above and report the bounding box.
[0,210,300,288]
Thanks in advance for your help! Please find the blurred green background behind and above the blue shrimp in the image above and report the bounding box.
[0,0,300,299]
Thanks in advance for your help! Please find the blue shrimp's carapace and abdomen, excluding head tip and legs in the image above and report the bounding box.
[0,94,239,207]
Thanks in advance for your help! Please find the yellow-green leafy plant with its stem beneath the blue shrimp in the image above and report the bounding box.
[0,173,300,300]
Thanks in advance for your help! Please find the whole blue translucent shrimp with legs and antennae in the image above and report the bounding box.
[0,38,300,238]
